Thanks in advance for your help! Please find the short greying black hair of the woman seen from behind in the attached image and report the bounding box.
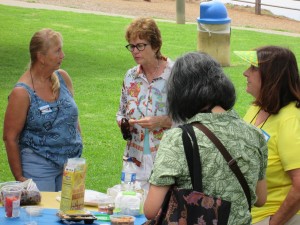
[167,52,236,122]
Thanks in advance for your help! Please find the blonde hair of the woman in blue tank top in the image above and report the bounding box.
[29,28,63,95]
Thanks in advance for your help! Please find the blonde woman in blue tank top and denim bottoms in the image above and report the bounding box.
[4,29,82,191]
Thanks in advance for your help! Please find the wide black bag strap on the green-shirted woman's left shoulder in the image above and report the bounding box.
[179,124,203,192]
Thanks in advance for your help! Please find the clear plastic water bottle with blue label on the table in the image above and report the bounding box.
[121,157,136,191]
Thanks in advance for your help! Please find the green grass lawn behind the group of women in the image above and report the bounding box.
[0,5,300,192]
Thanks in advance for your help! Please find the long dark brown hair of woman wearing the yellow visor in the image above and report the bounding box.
[254,45,300,114]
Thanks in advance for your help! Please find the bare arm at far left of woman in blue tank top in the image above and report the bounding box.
[3,87,29,181]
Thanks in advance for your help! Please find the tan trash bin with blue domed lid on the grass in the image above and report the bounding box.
[197,1,231,66]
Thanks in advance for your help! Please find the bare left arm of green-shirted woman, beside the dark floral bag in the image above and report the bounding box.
[144,184,170,219]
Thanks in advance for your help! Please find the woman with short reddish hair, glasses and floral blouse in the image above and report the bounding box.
[117,17,173,190]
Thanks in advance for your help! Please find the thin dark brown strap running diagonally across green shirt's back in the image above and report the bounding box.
[192,122,251,211]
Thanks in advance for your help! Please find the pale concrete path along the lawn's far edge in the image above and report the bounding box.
[0,0,300,37]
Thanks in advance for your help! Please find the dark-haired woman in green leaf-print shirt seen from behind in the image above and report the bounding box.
[144,52,267,225]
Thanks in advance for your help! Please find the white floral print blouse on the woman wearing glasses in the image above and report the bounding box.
[117,59,173,165]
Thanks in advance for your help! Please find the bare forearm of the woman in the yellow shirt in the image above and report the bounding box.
[270,169,300,225]
